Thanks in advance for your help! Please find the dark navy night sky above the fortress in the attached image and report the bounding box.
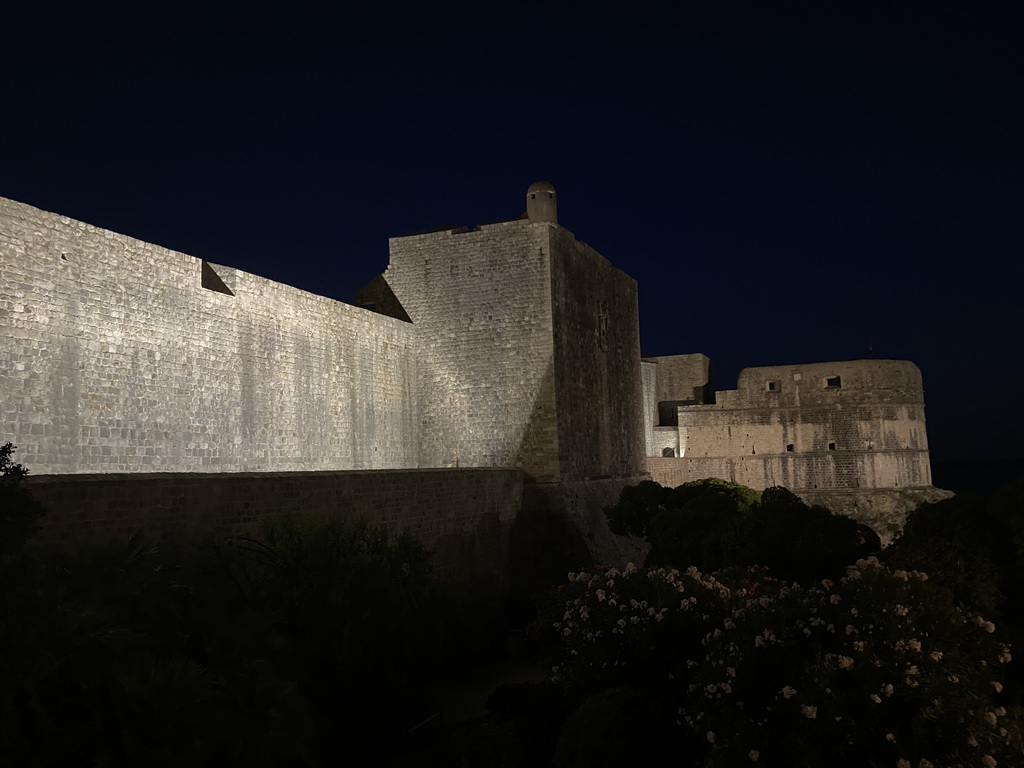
[0,0,1024,460]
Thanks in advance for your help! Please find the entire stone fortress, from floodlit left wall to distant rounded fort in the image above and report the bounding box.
[0,181,934,561]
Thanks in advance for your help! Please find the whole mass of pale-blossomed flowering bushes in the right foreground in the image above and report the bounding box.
[540,558,1022,768]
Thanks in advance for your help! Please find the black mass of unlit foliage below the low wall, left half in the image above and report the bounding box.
[0,446,509,768]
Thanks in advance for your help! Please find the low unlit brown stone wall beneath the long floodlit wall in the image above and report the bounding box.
[27,468,523,589]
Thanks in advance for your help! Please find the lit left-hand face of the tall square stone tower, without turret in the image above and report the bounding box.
[384,220,558,478]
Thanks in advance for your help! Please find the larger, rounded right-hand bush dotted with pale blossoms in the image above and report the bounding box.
[680,558,1022,768]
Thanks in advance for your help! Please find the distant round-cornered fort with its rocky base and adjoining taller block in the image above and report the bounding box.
[643,354,946,540]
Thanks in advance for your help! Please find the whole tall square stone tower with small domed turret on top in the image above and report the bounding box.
[359,182,644,483]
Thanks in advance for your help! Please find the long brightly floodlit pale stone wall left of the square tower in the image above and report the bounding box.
[0,199,419,474]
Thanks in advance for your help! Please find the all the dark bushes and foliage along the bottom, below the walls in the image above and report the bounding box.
[0,445,1024,768]
